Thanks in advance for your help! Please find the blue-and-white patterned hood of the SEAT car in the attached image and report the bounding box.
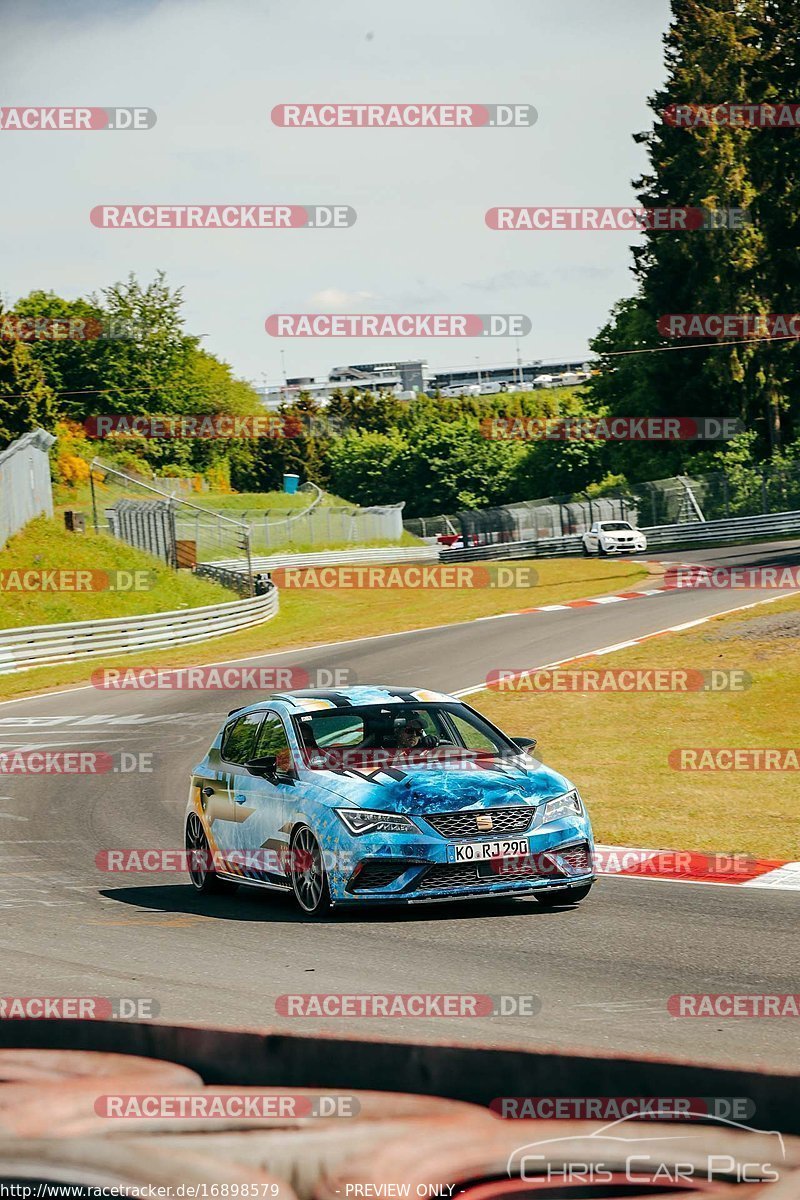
[309,757,572,816]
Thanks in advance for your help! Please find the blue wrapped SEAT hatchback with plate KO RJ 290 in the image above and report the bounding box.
[186,686,595,914]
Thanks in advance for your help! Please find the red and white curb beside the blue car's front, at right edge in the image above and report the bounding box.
[595,846,800,892]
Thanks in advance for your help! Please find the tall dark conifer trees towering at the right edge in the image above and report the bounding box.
[591,0,800,465]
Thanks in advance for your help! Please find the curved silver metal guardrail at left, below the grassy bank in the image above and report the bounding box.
[0,588,278,676]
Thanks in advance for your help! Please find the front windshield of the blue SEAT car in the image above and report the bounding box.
[294,703,519,770]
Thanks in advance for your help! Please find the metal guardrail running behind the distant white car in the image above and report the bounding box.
[441,511,800,563]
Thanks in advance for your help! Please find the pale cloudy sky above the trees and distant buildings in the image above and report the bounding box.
[0,0,669,384]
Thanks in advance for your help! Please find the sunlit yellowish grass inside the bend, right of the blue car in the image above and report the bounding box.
[468,588,800,860]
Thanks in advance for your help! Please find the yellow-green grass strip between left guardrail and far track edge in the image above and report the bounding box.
[0,554,645,708]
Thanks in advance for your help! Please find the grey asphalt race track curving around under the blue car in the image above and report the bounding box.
[0,542,800,1067]
